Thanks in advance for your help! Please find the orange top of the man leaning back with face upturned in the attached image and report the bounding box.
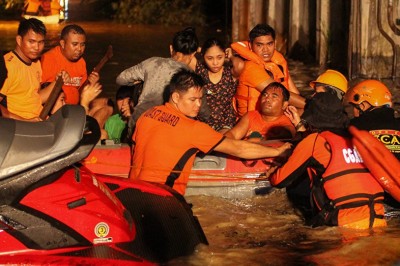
[246,111,296,139]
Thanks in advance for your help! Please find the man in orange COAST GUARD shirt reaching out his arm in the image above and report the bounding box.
[129,69,291,195]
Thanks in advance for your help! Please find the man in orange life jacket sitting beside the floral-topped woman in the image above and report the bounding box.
[231,24,305,116]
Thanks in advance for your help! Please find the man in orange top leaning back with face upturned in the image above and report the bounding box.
[225,82,296,140]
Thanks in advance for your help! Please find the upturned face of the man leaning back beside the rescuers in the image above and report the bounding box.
[260,88,288,116]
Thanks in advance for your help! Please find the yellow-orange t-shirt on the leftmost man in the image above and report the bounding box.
[0,52,43,119]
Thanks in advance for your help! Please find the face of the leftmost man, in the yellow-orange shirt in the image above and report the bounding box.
[16,30,45,63]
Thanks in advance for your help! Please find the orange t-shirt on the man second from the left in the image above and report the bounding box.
[41,46,87,104]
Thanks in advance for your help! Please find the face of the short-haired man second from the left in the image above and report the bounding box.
[60,32,86,62]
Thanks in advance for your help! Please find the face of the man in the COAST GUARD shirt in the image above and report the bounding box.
[172,87,203,117]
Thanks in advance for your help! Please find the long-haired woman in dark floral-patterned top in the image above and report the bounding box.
[194,38,237,133]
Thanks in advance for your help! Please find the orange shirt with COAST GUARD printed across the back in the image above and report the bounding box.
[129,103,224,195]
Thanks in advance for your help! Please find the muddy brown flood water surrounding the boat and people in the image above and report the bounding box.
[0,21,400,266]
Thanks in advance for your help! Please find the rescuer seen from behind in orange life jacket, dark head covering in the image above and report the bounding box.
[270,92,386,229]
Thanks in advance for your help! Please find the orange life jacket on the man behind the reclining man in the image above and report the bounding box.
[231,41,289,116]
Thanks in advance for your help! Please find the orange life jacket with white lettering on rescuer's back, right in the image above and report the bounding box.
[311,131,386,228]
